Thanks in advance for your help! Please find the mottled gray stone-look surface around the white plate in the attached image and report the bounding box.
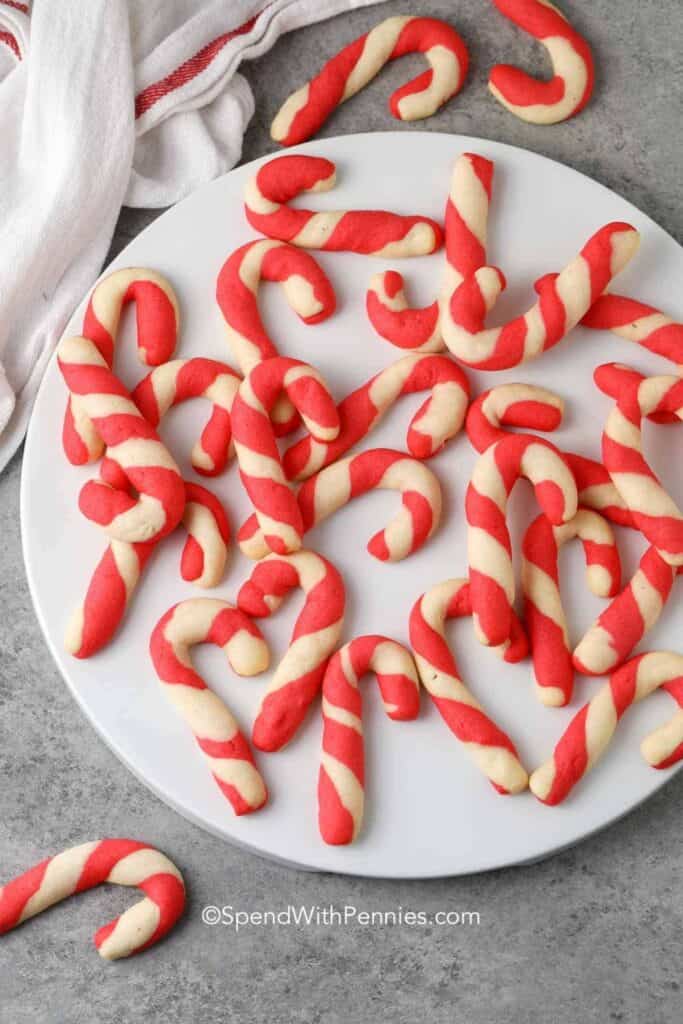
[0,0,683,1024]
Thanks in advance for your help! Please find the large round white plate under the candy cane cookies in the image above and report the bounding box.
[22,132,683,878]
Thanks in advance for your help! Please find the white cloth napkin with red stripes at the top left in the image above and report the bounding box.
[0,0,381,470]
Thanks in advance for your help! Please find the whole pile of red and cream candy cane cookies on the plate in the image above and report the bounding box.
[45,134,683,856]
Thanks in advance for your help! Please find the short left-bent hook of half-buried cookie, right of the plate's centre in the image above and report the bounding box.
[465,384,564,453]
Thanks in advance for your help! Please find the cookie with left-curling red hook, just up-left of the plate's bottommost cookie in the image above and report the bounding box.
[238,551,346,751]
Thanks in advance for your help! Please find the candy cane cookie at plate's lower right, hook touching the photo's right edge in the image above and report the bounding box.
[529,650,683,806]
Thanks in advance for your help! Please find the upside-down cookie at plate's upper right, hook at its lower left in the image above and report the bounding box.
[440,221,640,370]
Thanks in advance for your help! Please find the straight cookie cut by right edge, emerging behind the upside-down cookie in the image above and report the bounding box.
[581,293,683,372]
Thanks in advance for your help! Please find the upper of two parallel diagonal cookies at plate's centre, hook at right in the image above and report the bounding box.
[283,353,470,480]
